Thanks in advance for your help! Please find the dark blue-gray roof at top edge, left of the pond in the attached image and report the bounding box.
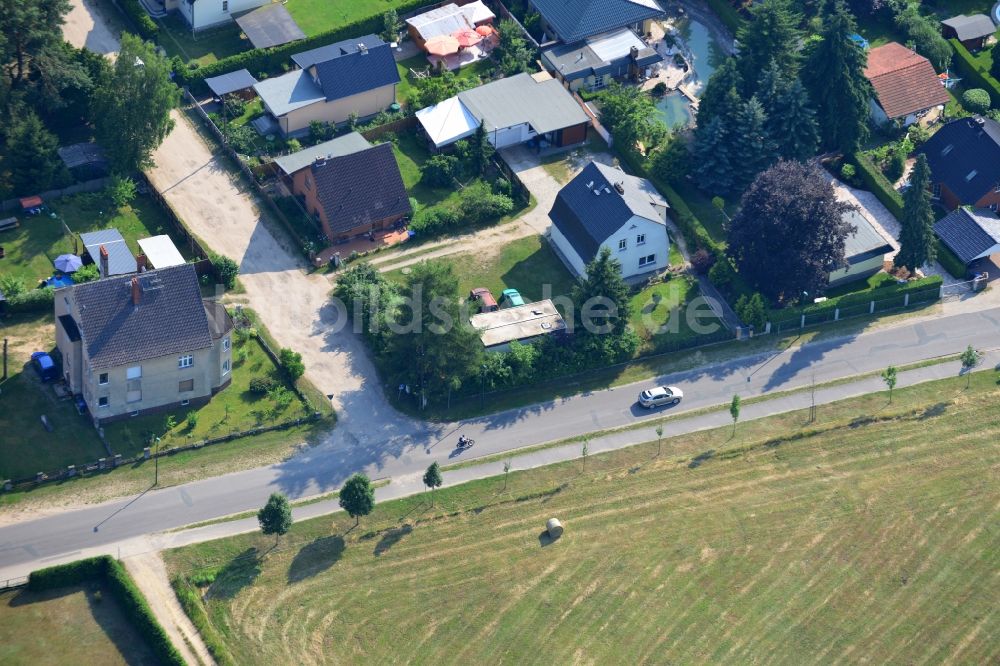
[530,0,663,44]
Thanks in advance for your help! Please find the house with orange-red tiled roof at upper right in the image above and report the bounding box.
[865,42,951,127]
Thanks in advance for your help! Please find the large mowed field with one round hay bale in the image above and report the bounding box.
[166,372,1000,664]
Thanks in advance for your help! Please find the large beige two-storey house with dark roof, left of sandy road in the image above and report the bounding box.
[55,264,233,424]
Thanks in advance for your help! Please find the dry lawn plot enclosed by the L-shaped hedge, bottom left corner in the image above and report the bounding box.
[0,582,158,666]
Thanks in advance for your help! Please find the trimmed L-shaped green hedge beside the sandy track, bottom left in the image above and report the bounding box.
[28,555,185,666]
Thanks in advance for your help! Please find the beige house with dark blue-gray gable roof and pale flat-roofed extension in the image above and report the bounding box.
[254,35,400,135]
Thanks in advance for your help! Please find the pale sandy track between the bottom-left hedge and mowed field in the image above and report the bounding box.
[122,552,215,665]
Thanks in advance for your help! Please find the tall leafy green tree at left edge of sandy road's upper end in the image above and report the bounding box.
[91,33,180,174]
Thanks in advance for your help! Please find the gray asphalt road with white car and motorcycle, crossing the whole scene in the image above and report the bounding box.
[0,308,1000,568]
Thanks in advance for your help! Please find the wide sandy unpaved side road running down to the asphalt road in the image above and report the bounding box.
[148,111,422,444]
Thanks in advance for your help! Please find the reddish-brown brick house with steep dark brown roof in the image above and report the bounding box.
[292,143,412,242]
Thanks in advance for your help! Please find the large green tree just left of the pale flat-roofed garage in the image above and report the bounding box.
[391,261,483,400]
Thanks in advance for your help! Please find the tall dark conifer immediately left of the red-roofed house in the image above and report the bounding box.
[802,2,872,153]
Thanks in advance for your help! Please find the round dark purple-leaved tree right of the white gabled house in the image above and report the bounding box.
[727,161,855,301]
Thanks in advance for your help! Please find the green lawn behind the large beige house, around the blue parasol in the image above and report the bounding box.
[0,193,190,288]
